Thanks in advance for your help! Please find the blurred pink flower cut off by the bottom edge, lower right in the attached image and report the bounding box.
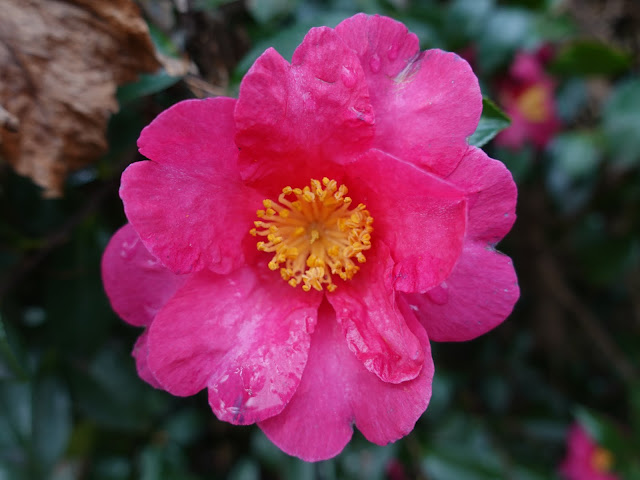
[560,424,618,480]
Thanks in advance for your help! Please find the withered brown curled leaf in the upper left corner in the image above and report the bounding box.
[0,0,159,197]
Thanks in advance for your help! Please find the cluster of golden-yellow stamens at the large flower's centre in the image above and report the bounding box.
[250,177,373,292]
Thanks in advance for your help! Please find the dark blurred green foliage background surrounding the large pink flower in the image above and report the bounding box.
[0,0,640,480]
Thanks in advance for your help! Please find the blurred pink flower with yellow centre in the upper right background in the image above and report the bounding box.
[496,48,561,148]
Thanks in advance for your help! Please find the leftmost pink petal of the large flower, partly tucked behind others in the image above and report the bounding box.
[102,224,186,326]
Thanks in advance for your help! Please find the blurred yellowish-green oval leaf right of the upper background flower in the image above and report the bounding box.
[550,40,631,76]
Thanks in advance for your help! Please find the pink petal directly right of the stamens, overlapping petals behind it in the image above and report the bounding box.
[346,150,467,292]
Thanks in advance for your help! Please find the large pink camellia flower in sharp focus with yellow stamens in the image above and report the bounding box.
[102,14,519,460]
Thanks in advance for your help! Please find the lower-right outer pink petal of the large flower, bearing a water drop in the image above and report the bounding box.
[405,242,520,342]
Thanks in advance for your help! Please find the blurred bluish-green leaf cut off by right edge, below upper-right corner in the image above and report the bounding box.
[603,79,640,167]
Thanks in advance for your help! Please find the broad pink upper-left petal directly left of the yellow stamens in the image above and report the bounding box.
[120,98,262,273]
